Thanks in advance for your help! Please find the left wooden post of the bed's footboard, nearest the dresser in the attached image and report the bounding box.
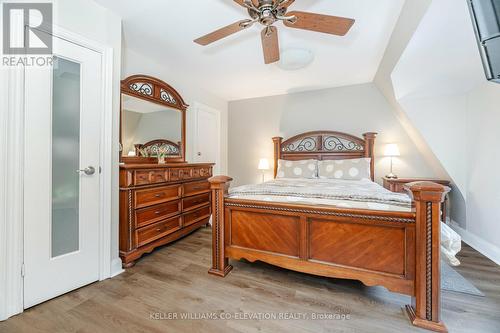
[208,176,233,277]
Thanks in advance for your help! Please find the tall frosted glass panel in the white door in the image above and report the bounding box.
[51,57,81,257]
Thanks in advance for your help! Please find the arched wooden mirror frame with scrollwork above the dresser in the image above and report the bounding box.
[120,75,189,164]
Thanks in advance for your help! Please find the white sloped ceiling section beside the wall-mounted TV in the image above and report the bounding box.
[392,0,485,100]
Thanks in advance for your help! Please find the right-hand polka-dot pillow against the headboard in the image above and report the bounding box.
[318,158,371,180]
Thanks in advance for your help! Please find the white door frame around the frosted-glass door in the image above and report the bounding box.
[0,25,115,320]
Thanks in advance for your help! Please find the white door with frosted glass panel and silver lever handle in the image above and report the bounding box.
[24,32,103,308]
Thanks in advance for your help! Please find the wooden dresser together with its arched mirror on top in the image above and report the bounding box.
[120,75,214,267]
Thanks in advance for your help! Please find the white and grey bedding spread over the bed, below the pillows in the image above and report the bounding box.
[229,178,461,266]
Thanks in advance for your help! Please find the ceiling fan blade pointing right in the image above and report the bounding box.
[283,11,355,36]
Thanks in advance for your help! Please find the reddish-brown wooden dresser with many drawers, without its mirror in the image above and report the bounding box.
[120,163,213,267]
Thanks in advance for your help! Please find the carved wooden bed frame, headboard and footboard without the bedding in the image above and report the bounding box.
[209,131,449,332]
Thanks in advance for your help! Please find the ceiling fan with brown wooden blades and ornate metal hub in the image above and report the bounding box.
[194,0,355,64]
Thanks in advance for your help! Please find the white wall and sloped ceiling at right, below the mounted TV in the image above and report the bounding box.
[383,0,500,263]
